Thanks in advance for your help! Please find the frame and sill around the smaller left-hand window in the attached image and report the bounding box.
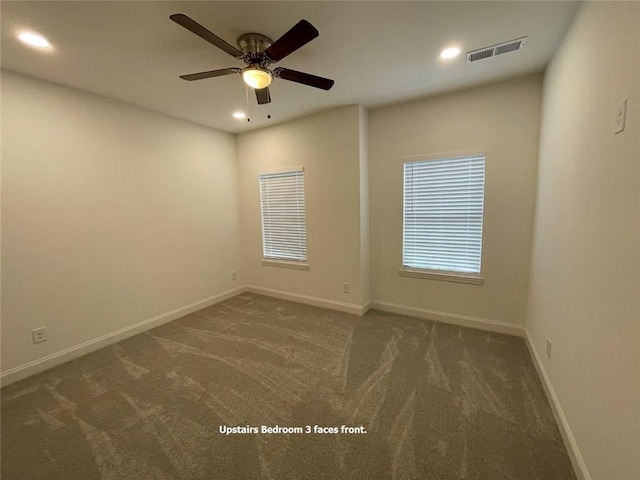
[258,166,309,270]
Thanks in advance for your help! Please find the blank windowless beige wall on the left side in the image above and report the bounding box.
[2,72,239,373]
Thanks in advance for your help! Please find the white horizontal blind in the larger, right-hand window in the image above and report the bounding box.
[402,154,485,274]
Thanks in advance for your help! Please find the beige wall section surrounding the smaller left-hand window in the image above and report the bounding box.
[237,105,367,308]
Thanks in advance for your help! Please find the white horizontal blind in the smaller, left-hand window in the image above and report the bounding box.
[260,169,307,262]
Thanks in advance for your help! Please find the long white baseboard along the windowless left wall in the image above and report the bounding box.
[0,287,245,386]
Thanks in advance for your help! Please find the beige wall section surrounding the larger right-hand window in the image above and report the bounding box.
[369,75,542,326]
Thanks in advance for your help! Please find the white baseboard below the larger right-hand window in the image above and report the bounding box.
[370,300,524,337]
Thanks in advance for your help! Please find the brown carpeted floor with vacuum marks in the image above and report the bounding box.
[1,294,575,480]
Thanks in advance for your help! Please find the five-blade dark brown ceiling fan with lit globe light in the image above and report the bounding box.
[169,13,334,105]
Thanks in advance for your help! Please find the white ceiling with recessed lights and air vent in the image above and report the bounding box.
[1,1,578,133]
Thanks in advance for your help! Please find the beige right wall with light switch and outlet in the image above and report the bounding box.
[527,2,640,480]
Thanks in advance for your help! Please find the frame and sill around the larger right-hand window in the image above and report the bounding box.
[399,149,487,285]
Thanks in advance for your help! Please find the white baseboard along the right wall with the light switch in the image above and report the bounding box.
[524,328,591,480]
